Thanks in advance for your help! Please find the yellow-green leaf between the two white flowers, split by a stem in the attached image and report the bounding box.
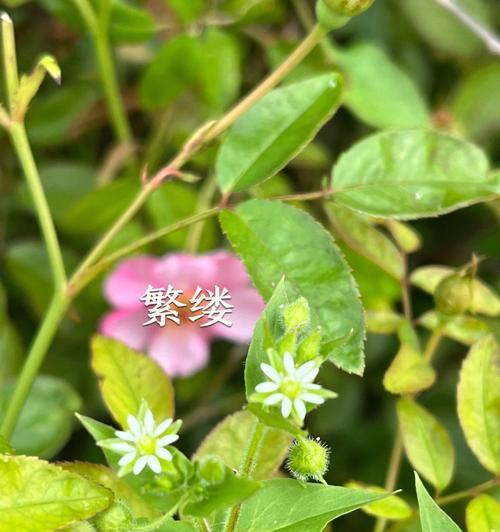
[193,411,292,480]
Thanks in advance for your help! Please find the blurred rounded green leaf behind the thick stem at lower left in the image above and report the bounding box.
[0,376,81,458]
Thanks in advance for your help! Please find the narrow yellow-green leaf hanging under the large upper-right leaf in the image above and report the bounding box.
[326,203,405,279]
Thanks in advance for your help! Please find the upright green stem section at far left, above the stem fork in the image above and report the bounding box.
[9,122,66,289]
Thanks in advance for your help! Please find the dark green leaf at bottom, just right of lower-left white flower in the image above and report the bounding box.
[182,467,261,517]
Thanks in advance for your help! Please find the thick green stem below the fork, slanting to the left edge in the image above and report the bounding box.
[0,291,69,439]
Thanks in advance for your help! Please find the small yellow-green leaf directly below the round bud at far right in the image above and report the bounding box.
[418,311,491,345]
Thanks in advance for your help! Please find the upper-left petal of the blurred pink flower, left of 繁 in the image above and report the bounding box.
[104,257,163,308]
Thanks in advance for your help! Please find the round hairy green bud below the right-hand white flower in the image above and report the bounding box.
[286,438,330,481]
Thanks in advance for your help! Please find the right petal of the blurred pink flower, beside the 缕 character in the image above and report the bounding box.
[211,287,265,343]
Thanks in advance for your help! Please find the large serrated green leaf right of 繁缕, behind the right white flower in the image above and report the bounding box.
[220,200,364,375]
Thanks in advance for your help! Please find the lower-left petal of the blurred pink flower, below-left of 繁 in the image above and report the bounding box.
[99,308,151,350]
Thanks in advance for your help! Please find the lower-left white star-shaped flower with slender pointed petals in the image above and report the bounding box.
[97,403,182,476]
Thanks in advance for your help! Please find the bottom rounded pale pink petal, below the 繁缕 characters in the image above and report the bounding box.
[148,326,210,377]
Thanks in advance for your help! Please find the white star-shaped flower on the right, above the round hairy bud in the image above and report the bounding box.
[255,352,335,422]
